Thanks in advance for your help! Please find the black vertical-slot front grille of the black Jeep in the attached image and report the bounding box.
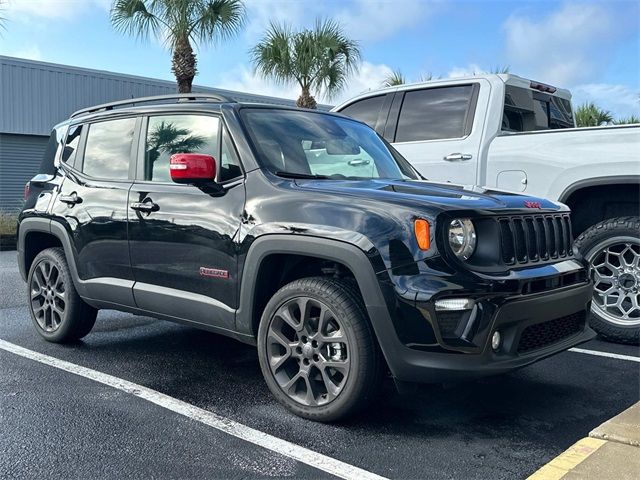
[498,214,573,265]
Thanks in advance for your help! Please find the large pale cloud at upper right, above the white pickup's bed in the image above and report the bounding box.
[504,3,615,86]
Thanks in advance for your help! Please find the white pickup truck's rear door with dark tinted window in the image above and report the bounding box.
[384,80,488,185]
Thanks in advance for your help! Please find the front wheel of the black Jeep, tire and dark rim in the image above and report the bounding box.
[258,277,382,422]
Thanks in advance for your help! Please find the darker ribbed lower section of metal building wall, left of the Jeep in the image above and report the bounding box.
[0,134,49,213]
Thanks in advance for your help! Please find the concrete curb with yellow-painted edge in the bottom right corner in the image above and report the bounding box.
[528,402,640,480]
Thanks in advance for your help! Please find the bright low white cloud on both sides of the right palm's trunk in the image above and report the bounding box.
[215,62,391,105]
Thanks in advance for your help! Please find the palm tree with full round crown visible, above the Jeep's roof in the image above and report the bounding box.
[250,20,360,108]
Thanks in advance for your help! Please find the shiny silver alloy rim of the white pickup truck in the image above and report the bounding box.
[587,237,640,326]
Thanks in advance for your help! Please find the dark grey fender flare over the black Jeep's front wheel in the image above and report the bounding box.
[236,234,404,373]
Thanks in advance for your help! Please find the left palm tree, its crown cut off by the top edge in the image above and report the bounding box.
[111,0,245,93]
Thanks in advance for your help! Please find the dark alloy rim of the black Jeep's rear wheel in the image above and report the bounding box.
[30,260,66,332]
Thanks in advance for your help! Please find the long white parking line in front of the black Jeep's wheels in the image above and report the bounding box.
[0,339,386,480]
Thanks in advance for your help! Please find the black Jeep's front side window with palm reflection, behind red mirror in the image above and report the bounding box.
[144,115,220,182]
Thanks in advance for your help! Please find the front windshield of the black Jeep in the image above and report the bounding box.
[241,109,418,179]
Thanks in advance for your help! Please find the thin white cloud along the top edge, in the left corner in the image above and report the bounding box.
[6,0,112,20]
